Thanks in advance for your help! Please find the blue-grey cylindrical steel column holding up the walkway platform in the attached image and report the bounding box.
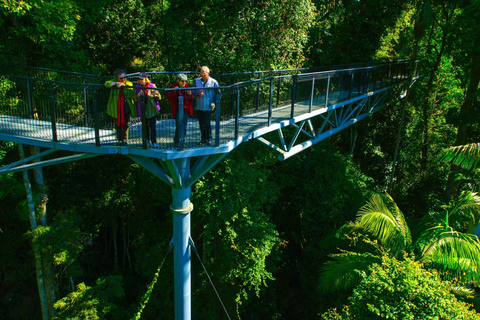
[170,158,193,320]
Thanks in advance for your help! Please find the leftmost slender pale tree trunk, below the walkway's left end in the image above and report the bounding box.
[18,144,50,320]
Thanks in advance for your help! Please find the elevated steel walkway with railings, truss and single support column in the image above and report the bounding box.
[0,60,418,320]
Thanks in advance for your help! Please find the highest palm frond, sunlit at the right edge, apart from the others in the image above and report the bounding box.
[439,143,480,171]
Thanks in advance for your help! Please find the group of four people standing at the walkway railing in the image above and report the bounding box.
[105,66,220,150]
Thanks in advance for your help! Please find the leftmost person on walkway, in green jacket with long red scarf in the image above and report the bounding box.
[105,69,137,145]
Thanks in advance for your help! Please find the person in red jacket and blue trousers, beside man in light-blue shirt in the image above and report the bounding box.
[167,73,194,150]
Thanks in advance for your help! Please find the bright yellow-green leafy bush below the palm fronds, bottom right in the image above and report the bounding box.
[322,257,479,320]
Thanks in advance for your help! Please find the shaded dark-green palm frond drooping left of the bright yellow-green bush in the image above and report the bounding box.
[320,251,382,292]
